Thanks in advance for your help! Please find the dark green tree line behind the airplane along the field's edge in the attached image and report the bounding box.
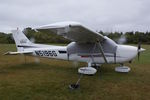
[0,28,150,44]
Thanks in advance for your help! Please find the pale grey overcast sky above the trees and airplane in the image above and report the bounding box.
[0,0,150,32]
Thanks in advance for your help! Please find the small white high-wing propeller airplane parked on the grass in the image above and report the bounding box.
[6,22,145,89]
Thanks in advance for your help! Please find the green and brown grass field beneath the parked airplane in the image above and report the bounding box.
[0,44,150,100]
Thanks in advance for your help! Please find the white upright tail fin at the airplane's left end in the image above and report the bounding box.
[12,29,33,51]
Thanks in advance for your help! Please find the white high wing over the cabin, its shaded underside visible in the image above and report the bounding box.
[35,22,104,43]
